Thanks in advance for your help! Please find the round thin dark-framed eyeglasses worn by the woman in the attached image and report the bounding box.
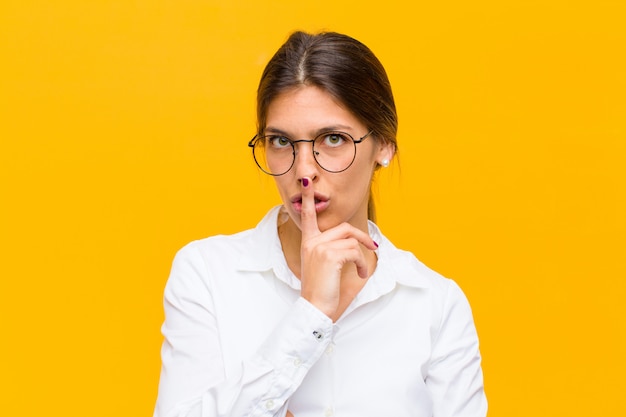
[248,130,373,177]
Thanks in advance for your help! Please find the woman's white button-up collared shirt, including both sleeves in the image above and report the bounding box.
[154,207,487,417]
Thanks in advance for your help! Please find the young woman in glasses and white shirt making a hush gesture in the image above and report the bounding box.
[155,32,487,417]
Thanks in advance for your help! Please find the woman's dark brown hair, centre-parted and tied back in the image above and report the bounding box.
[257,32,398,220]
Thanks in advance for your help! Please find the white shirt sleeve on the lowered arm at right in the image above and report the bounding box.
[426,281,487,417]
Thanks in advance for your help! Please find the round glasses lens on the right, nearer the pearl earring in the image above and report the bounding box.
[313,132,356,172]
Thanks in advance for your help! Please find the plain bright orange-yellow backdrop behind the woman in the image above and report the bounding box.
[0,0,626,417]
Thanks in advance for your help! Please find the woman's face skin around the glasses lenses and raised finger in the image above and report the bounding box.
[264,86,393,231]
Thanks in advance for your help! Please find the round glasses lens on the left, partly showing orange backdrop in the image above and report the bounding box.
[252,136,294,175]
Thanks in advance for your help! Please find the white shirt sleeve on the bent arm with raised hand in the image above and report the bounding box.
[154,244,333,417]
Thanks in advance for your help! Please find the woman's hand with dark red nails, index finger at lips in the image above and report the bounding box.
[300,178,377,318]
